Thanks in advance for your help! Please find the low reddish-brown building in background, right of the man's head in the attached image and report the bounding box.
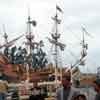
[72,67,97,87]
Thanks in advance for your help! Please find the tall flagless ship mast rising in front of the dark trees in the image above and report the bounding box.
[26,9,36,81]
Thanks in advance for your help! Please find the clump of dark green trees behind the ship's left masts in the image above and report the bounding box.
[4,46,48,69]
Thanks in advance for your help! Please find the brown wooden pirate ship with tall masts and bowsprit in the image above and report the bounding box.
[0,5,88,84]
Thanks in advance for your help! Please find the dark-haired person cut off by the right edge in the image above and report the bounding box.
[93,79,100,100]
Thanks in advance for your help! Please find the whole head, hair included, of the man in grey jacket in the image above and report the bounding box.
[62,71,71,88]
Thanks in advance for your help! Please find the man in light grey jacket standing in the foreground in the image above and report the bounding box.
[56,71,80,100]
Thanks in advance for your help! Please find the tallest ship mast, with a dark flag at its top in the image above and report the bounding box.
[48,5,65,88]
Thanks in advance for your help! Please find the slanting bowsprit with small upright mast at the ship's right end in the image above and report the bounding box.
[71,27,88,86]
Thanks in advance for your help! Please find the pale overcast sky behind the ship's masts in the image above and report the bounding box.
[0,0,100,73]
